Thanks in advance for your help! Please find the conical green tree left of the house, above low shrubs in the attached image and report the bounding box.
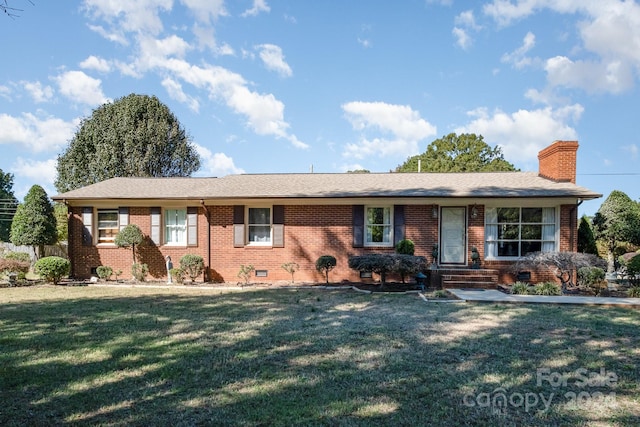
[11,185,58,258]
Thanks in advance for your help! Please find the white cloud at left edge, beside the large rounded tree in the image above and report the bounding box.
[0,113,80,152]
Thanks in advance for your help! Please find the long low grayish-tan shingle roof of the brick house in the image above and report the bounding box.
[53,172,602,201]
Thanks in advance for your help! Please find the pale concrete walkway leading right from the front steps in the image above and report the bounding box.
[447,289,640,308]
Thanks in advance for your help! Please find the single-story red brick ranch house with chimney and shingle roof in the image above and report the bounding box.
[53,141,602,284]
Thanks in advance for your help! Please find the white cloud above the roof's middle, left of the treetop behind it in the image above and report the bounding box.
[342,101,436,159]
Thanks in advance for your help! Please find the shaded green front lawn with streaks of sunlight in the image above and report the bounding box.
[0,286,640,426]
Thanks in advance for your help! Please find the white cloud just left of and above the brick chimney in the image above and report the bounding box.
[455,104,584,165]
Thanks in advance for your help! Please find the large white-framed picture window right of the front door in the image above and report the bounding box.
[485,207,558,258]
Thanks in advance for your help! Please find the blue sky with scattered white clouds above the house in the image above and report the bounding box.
[0,0,640,214]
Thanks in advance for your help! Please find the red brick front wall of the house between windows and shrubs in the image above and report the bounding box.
[69,205,577,283]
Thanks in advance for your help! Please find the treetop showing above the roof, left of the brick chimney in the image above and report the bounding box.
[396,133,517,172]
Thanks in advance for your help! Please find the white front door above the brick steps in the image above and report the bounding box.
[440,207,467,265]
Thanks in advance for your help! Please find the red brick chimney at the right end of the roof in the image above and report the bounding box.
[538,141,578,184]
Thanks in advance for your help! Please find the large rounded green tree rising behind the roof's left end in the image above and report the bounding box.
[55,94,200,192]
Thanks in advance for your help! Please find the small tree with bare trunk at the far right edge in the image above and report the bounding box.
[593,190,640,273]
